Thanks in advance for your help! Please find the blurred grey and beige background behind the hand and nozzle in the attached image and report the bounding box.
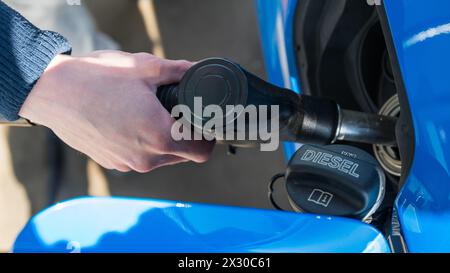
[0,0,285,251]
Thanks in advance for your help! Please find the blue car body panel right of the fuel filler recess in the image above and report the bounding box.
[385,0,450,252]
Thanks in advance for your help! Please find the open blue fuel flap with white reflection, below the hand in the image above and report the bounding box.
[13,198,389,253]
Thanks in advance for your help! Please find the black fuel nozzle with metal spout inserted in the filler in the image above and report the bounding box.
[157,58,396,146]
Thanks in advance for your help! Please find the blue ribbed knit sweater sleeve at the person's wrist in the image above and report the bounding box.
[0,1,71,121]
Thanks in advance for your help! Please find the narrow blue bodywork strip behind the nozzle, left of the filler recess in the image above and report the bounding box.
[256,0,301,160]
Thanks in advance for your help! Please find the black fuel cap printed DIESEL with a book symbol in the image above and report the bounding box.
[286,145,385,220]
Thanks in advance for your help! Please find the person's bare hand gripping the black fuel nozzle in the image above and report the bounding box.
[19,51,214,172]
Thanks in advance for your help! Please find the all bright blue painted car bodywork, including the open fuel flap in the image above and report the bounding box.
[14,0,450,253]
